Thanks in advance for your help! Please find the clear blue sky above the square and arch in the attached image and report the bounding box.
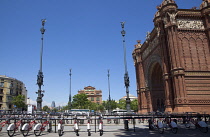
[0,0,202,106]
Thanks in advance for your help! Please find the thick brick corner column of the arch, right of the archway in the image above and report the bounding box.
[165,12,191,112]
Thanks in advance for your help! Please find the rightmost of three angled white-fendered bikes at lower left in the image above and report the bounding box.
[34,117,52,136]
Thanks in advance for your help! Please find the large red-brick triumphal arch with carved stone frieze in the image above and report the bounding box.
[133,0,210,113]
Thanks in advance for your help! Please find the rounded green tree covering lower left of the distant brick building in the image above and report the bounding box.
[72,93,91,109]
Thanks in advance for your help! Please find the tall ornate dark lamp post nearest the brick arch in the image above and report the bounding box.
[121,22,131,113]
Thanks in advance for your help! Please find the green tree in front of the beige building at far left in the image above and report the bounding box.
[12,94,26,108]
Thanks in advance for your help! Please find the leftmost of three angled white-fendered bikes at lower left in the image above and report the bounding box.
[7,119,23,137]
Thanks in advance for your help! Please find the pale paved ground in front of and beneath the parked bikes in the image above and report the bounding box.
[0,124,210,137]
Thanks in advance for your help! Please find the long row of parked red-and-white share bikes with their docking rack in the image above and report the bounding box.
[0,113,210,136]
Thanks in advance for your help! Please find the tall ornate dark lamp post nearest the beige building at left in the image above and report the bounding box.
[36,19,46,111]
